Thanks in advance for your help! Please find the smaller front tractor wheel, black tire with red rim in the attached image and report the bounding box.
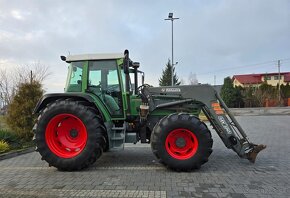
[151,113,213,171]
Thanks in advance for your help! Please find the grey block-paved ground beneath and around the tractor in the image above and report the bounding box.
[0,116,290,198]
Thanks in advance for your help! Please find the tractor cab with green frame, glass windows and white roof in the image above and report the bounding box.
[61,51,144,119]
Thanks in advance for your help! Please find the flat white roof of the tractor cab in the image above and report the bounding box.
[66,53,124,62]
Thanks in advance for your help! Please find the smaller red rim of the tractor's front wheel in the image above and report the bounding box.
[165,129,198,160]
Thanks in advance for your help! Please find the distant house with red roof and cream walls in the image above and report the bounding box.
[233,72,290,87]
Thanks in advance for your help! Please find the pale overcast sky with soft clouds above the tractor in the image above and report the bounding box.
[0,0,290,92]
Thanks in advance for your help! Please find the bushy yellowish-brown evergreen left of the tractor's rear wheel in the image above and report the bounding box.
[6,81,43,141]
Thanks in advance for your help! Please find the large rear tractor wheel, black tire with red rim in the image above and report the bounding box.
[35,99,106,171]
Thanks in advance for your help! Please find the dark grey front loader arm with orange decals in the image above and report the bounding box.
[145,85,266,163]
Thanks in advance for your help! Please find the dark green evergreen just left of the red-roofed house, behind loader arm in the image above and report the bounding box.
[221,77,243,107]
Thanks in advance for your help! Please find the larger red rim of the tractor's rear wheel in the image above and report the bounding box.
[45,114,87,158]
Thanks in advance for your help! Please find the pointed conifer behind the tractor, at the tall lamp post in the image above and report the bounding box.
[159,59,180,86]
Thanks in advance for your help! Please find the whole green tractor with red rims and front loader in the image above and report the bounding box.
[33,50,266,171]
